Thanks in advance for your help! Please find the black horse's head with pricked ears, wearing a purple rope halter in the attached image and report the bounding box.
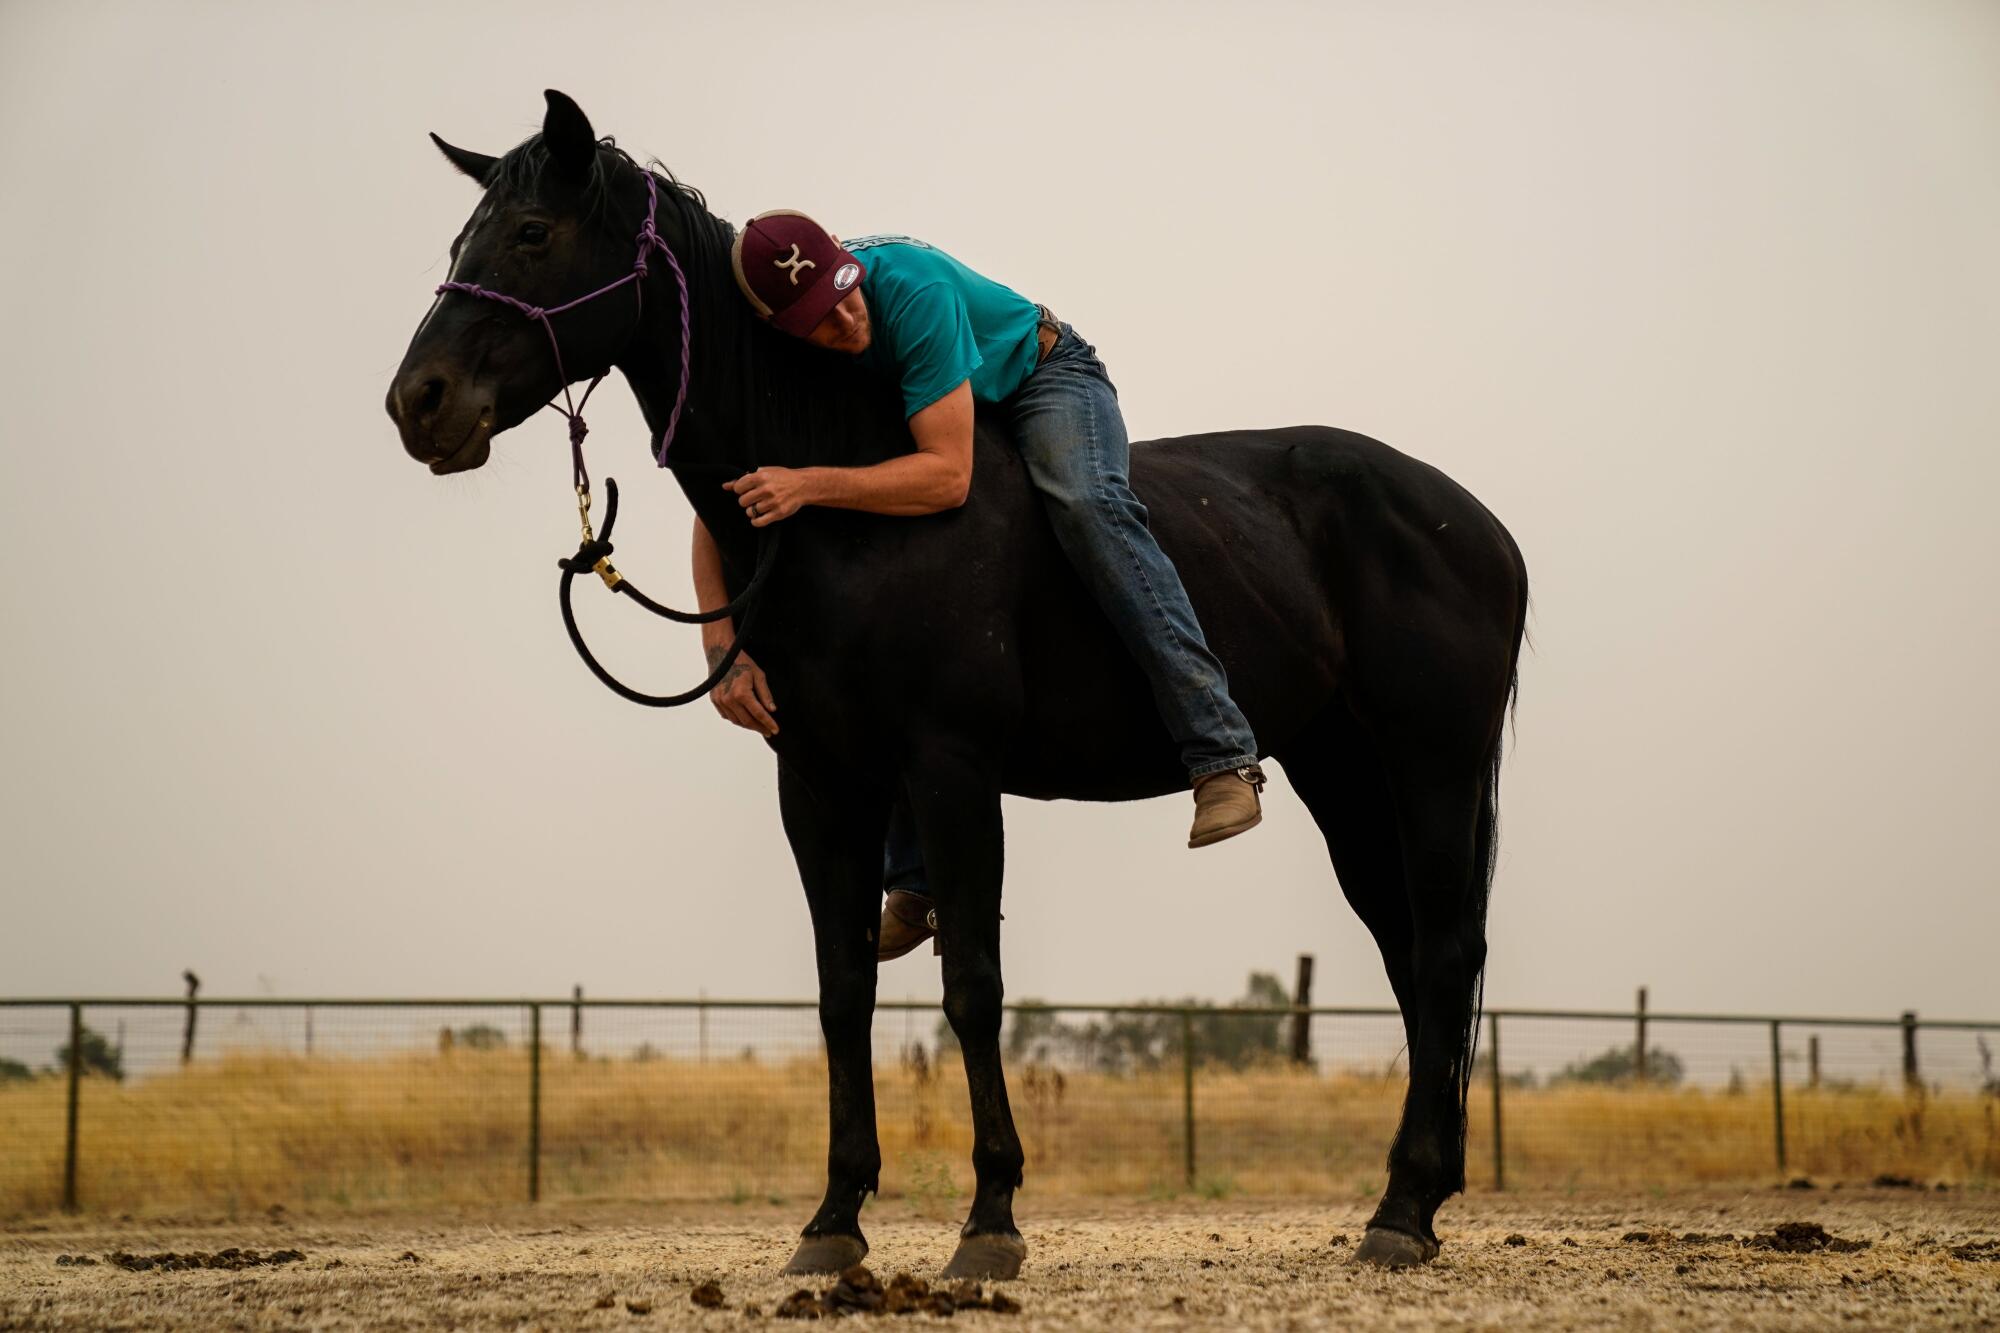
[388,90,644,474]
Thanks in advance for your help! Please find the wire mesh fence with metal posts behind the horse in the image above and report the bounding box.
[0,999,2000,1215]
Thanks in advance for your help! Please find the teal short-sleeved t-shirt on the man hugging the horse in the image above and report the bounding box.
[840,236,1040,416]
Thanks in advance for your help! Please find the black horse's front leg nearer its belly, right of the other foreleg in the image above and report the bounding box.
[908,755,1028,1277]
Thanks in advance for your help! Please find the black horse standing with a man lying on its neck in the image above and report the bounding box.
[388,92,1528,1277]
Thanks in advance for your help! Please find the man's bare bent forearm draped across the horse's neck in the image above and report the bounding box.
[724,380,972,524]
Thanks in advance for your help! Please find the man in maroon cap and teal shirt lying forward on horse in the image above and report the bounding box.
[694,208,1264,959]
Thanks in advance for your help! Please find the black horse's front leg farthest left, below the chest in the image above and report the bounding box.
[778,765,888,1273]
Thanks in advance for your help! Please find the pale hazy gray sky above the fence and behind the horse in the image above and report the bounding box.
[0,0,2000,1017]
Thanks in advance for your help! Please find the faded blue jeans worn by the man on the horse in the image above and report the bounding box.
[884,324,1256,893]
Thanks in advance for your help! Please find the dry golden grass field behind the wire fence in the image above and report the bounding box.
[0,1049,2000,1217]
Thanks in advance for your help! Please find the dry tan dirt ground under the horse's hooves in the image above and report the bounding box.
[0,1191,2000,1333]
